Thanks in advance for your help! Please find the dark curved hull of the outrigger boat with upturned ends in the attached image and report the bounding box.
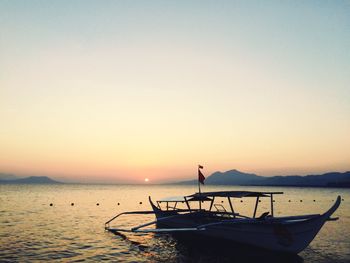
[151,197,340,254]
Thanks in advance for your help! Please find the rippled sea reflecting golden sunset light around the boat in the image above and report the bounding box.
[0,185,350,262]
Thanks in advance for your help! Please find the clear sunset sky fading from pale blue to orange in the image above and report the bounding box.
[0,0,350,183]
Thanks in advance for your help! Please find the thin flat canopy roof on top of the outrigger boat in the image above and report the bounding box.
[158,191,283,202]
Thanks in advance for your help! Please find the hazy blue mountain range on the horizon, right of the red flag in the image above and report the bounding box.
[175,170,350,188]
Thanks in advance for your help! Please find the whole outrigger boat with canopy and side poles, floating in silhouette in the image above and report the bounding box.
[105,191,341,254]
